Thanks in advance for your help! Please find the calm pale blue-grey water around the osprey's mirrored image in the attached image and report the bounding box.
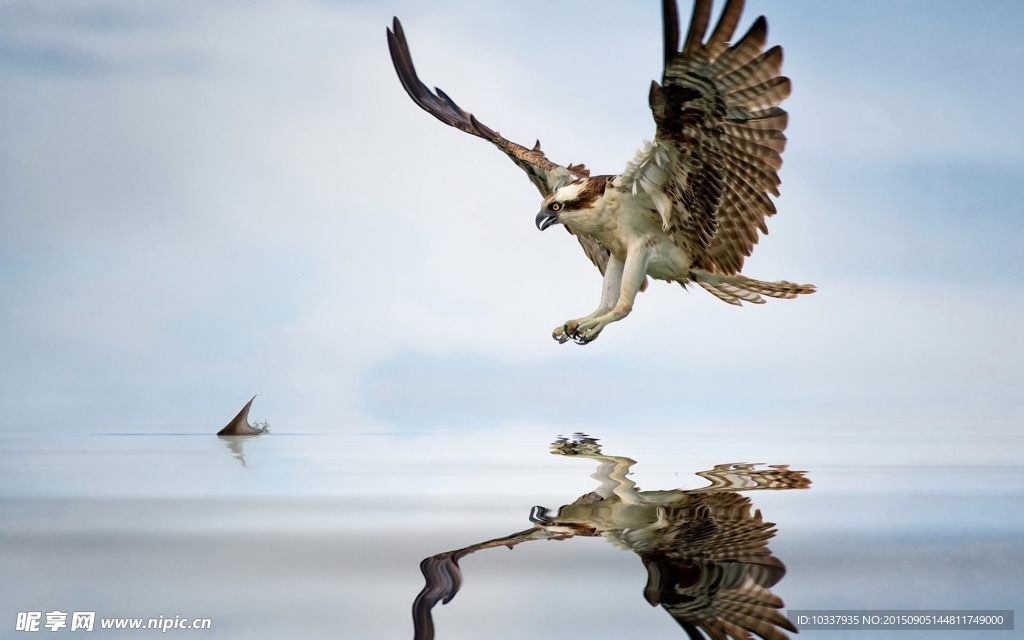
[0,425,1024,638]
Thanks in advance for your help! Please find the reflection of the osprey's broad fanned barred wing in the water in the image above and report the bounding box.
[624,493,797,640]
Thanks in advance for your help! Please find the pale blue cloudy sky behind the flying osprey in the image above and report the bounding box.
[0,0,1024,432]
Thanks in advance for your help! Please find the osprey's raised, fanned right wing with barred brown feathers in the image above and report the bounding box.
[623,0,790,274]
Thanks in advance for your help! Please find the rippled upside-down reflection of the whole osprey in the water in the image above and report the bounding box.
[413,433,811,640]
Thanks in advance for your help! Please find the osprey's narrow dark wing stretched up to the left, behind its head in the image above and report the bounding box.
[387,17,608,275]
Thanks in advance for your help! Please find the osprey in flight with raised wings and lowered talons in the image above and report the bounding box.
[387,0,815,344]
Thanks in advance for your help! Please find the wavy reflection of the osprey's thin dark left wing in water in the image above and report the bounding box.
[413,527,571,640]
